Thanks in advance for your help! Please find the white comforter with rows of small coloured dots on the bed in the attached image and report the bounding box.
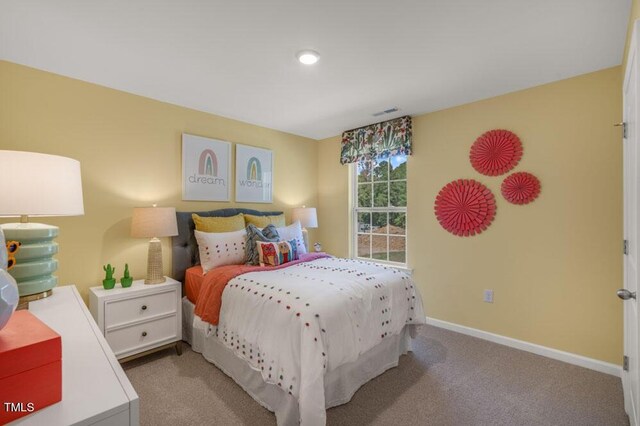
[217,258,425,426]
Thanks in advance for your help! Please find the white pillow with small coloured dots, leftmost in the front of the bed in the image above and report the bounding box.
[194,229,247,274]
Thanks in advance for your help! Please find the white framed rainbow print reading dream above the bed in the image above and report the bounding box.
[182,133,231,201]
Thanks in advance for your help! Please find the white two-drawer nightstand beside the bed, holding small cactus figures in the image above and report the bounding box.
[89,277,182,362]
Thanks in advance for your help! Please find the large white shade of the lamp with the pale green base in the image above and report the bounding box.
[0,151,84,217]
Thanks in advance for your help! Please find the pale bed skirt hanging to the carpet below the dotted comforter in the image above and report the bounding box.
[182,297,415,426]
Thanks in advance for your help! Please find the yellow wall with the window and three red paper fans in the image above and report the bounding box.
[318,67,622,364]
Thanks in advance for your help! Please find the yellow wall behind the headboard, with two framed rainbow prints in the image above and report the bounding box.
[0,61,317,300]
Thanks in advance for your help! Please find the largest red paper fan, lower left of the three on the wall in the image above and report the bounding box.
[434,179,496,237]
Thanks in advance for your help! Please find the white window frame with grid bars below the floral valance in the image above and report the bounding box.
[349,155,410,270]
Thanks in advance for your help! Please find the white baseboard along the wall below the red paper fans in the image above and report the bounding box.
[427,317,622,377]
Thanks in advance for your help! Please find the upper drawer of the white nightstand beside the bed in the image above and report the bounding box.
[104,288,179,330]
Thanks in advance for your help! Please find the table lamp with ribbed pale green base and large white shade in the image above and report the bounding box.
[0,150,84,304]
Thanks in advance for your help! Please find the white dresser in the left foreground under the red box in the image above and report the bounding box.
[10,286,139,426]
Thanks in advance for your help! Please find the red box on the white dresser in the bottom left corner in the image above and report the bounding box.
[0,311,62,424]
